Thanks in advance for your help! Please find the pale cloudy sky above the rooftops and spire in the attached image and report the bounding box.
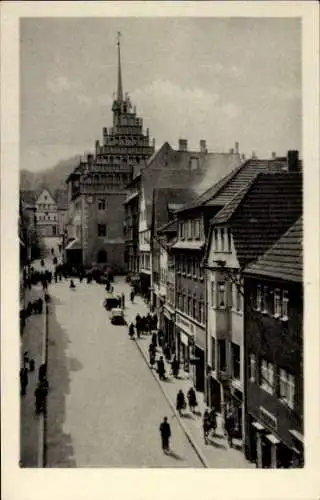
[20,17,302,172]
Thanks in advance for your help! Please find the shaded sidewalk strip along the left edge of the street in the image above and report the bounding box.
[20,286,45,467]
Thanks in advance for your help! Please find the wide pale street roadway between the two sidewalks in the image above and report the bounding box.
[47,277,202,467]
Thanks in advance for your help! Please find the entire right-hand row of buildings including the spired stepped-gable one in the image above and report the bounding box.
[62,38,304,467]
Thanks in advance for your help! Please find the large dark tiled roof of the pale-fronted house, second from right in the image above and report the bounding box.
[211,172,303,267]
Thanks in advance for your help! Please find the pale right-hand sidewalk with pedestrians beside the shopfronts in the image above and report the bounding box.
[127,297,255,469]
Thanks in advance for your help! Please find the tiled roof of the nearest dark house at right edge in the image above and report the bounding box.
[245,217,303,283]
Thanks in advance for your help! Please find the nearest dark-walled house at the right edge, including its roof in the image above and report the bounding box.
[243,217,304,468]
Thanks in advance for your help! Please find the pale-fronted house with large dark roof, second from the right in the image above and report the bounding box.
[205,169,302,444]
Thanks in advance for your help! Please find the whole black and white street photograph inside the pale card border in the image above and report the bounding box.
[3,2,318,500]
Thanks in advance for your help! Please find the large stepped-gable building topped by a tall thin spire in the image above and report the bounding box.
[66,33,154,272]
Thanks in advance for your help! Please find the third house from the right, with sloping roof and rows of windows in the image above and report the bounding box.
[173,150,298,396]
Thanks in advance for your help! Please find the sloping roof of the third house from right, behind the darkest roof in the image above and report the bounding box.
[181,158,287,212]
